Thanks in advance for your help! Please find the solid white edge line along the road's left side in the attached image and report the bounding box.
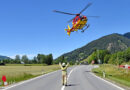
[2,70,59,90]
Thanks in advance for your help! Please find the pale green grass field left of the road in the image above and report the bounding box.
[0,64,60,84]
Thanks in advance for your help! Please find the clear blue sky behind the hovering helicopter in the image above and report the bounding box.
[0,0,130,58]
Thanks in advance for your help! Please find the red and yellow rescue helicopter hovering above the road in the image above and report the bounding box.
[54,3,98,36]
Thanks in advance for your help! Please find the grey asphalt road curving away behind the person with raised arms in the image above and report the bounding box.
[4,65,121,90]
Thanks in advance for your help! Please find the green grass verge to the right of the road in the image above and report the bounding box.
[92,65,130,87]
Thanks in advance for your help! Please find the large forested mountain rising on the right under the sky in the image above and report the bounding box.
[57,33,130,61]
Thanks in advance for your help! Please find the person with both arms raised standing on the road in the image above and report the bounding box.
[59,63,69,86]
